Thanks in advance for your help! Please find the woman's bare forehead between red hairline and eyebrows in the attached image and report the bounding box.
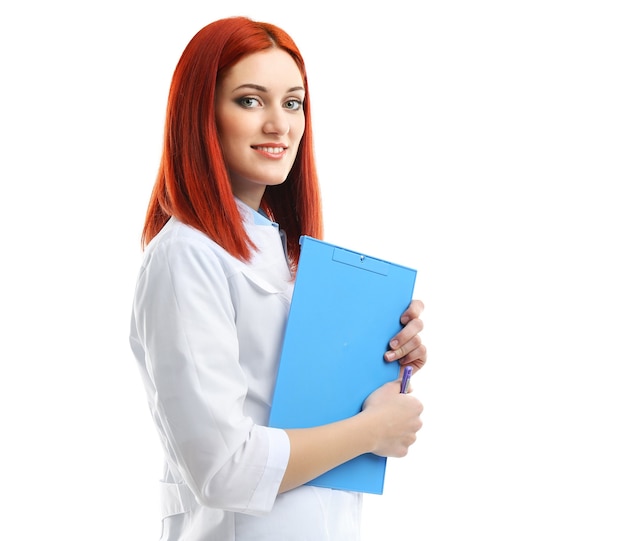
[222,49,304,88]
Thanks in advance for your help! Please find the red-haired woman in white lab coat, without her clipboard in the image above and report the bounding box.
[131,17,426,541]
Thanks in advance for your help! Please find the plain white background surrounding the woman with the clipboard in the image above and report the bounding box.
[0,0,626,541]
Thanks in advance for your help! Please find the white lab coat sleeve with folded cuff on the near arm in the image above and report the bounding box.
[131,231,289,514]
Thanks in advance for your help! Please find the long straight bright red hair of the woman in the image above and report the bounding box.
[142,17,323,265]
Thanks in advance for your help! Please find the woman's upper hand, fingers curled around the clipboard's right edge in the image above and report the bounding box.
[385,300,426,370]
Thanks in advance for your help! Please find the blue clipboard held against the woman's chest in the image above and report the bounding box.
[269,235,417,494]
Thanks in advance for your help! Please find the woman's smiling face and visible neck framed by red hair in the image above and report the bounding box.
[216,49,305,209]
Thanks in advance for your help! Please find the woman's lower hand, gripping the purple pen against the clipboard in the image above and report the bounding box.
[361,380,424,457]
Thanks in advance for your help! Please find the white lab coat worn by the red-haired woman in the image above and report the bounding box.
[130,201,361,541]
